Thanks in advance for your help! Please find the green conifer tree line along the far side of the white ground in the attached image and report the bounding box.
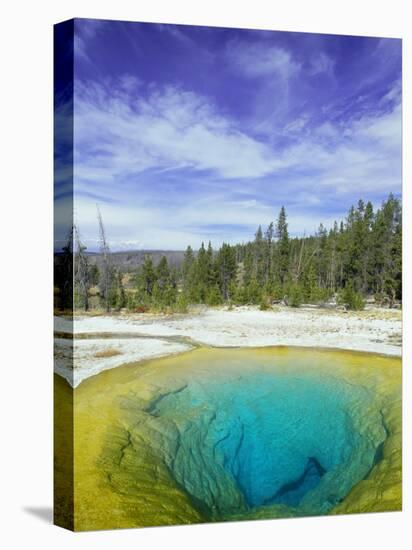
[54,195,402,312]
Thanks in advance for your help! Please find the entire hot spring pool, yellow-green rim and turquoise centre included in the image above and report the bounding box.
[55,348,402,530]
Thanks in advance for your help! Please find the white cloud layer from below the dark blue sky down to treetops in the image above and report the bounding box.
[71,77,401,248]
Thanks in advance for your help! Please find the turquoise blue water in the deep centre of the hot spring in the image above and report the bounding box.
[147,366,386,518]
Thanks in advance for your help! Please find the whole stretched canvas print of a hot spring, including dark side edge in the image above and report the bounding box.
[54,19,402,531]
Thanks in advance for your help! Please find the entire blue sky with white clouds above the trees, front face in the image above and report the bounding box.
[62,19,401,250]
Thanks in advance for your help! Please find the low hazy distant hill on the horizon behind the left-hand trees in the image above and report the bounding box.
[88,250,185,272]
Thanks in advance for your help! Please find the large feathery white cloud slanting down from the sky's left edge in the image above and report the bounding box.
[75,82,279,181]
